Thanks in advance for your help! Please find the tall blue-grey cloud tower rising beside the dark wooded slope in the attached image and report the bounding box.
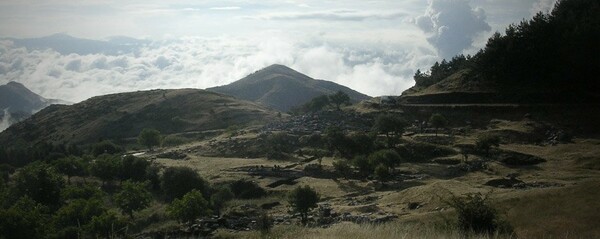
[415,0,491,58]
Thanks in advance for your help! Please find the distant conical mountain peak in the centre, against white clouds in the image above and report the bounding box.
[207,65,371,111]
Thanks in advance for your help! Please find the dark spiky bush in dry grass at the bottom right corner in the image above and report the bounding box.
[448,193,512,234]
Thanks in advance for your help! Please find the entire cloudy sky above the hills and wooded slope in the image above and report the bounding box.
[0,0,555,102]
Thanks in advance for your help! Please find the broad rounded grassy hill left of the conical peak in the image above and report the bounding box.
[0,89,275,145]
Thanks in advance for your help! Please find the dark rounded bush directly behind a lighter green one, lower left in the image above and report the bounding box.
[160,167,208,202]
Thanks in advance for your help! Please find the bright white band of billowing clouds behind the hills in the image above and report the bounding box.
[0,33,436,102]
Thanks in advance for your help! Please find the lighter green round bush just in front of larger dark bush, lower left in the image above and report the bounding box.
[167,189,212,223]
